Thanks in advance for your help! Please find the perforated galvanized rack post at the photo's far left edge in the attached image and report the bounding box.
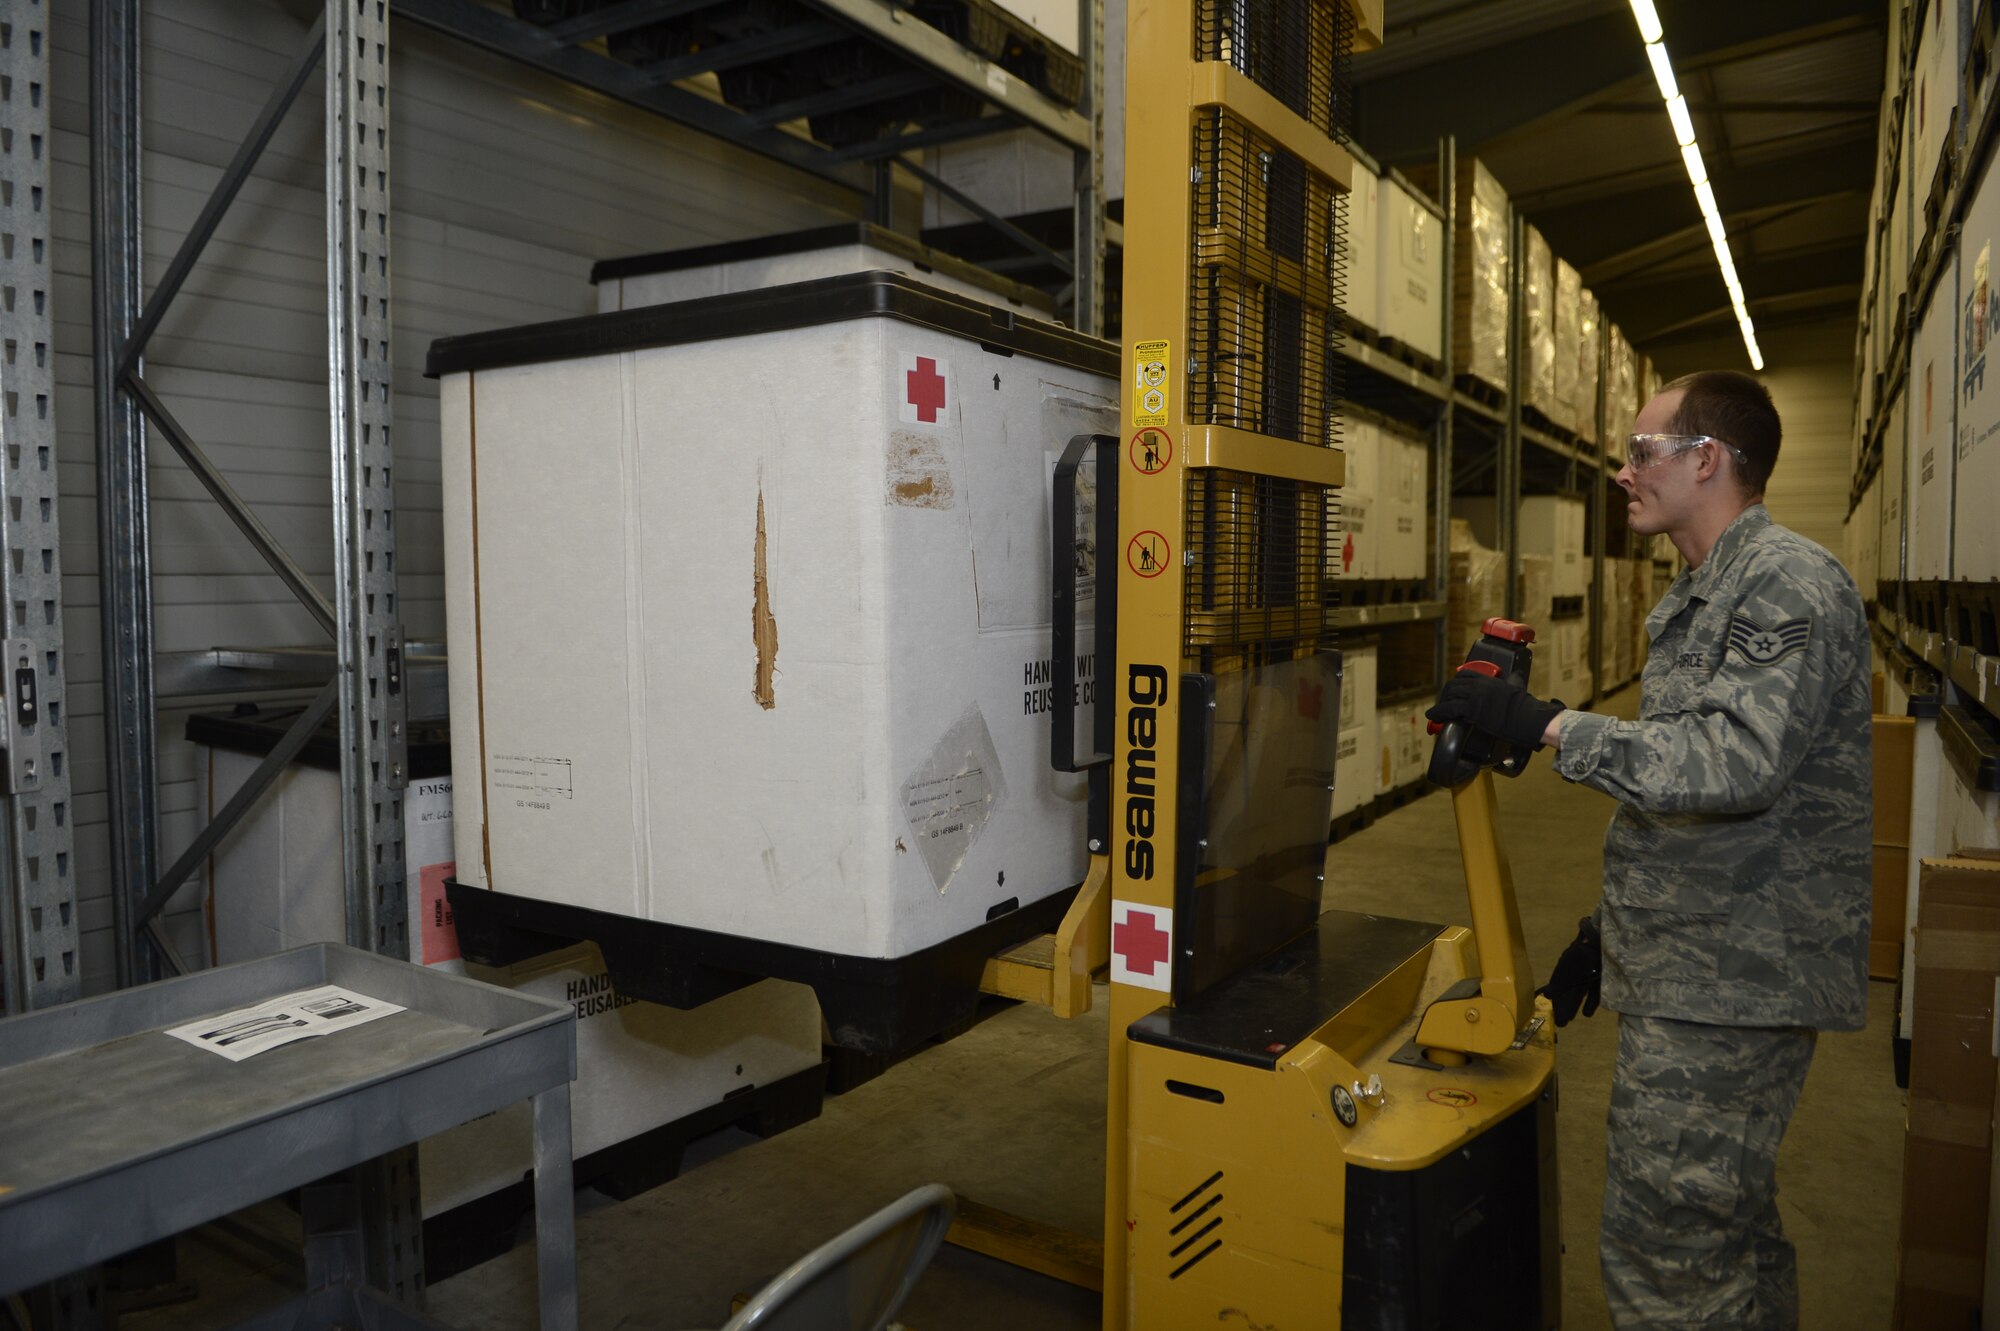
[0,0,82,1013]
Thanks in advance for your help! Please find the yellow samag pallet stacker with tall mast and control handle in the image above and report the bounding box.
[1088,0,1558,1331]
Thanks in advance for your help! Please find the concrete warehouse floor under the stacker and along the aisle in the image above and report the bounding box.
[126,691,1904,1331]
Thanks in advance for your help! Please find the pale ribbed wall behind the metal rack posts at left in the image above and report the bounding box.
[50,0,860,991]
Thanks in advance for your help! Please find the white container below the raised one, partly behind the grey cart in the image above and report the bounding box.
[416,943,820,1217]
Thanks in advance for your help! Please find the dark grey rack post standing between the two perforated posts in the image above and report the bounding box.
[90,0,160,987]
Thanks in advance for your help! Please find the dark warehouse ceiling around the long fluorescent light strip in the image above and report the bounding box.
[1354,0,1888,352]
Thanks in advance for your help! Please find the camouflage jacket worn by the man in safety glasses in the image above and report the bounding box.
[1556,504,1872,1031]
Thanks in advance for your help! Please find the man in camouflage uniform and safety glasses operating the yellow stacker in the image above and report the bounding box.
[1430,372,1870,1331]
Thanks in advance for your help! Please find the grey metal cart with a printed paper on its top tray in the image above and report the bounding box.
[0,943,576,1331]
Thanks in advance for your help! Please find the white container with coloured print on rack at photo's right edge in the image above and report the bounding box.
[1952,170,2000,582]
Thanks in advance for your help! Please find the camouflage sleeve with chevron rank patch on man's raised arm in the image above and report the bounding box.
[1556,560,1852,813]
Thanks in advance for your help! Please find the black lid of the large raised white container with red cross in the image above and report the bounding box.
[424,272,1120,378]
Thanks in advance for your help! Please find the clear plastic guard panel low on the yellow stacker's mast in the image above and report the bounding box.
[1174,652,1342,1003]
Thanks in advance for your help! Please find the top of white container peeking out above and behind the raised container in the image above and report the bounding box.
[590,222,1054,316]
